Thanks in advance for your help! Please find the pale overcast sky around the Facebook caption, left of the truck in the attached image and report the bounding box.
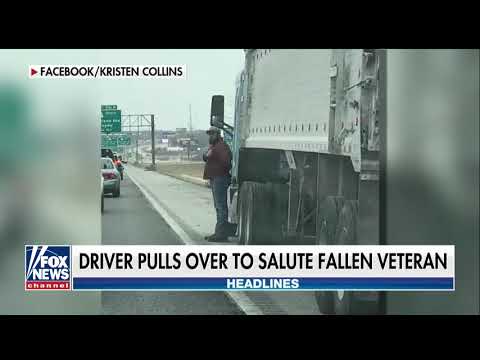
[0,49,244,129]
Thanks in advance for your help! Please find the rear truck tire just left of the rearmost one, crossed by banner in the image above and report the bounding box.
[315,196,344,315]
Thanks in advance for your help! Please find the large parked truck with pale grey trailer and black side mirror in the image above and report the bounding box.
[211,49,385,314]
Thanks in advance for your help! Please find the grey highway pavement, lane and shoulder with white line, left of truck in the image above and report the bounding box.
[102,164,320,315]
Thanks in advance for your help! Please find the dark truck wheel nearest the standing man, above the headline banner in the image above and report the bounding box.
[238,181,286,245]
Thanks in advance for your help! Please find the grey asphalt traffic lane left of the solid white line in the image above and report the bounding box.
[102,175,243,315]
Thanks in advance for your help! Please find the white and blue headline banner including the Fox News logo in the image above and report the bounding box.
[25,245,455,291]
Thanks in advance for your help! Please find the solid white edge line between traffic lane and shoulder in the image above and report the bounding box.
[128,174,264,315]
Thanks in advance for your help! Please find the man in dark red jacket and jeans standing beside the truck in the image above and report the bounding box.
[203,126,235,242]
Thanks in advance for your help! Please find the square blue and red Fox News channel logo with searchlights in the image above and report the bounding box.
[25,245,71,290]
